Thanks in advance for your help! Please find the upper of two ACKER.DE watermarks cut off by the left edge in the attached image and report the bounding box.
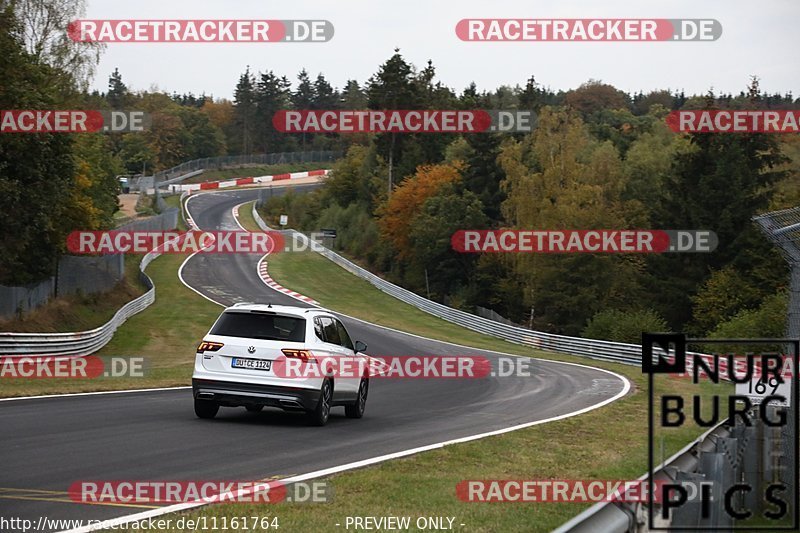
[0,109,152,133]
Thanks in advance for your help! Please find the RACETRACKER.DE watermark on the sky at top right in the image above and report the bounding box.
[456,18,722,42]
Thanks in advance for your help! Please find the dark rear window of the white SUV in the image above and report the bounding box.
[211,311,306,342]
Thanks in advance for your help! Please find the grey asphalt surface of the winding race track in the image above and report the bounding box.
[0,183,629,523]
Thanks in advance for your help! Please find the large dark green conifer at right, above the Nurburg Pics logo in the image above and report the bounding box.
[650,84,785,327]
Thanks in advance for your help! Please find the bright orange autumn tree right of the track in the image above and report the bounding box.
[378,162,461,259]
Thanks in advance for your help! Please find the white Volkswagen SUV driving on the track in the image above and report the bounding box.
[192,303,369,426]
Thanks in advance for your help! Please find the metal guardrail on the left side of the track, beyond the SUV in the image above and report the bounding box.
[0,245,166,358]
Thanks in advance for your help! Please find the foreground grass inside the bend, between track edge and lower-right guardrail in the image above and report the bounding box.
[112,370,720,532]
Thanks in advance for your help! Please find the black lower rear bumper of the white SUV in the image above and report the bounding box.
[192,378,320,411]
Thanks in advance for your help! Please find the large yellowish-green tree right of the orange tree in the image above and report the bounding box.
[499,107,644,334]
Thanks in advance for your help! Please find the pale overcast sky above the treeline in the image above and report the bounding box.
[86,0,800,98]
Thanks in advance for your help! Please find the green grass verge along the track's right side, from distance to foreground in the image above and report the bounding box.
[119,204,720,531]
